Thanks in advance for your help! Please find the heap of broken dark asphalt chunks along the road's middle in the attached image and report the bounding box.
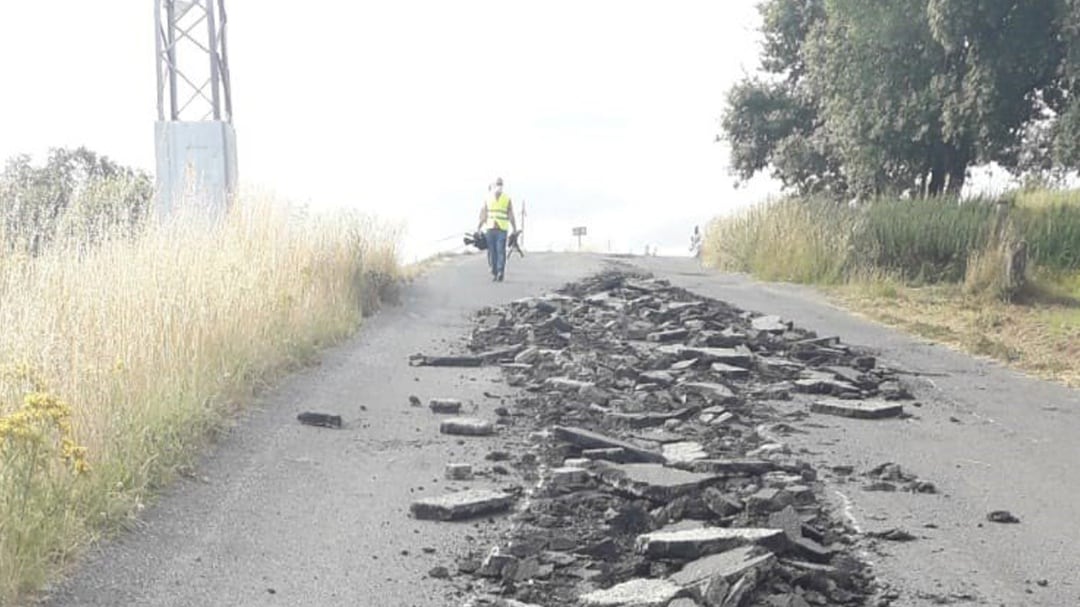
[410,271,920,607]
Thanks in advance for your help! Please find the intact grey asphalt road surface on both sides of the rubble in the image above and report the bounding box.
[43,254,1080,607]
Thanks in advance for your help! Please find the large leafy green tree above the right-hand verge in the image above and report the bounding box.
[723,0,1080,194]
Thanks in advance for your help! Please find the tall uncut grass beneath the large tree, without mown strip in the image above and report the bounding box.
[703,192,1080,293]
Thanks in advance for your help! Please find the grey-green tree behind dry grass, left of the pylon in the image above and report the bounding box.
[0,147,153,254]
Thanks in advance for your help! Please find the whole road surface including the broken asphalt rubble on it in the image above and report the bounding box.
[42,255,1080,607]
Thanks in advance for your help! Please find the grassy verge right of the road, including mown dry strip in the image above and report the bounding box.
[703,191,1080,386]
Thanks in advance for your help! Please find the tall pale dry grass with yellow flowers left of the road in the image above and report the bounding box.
[0,193,399,605]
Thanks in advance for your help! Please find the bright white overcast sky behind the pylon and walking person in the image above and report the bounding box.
[0,0,775,256]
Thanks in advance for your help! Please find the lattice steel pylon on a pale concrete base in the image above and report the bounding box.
[153,0,237,216]
